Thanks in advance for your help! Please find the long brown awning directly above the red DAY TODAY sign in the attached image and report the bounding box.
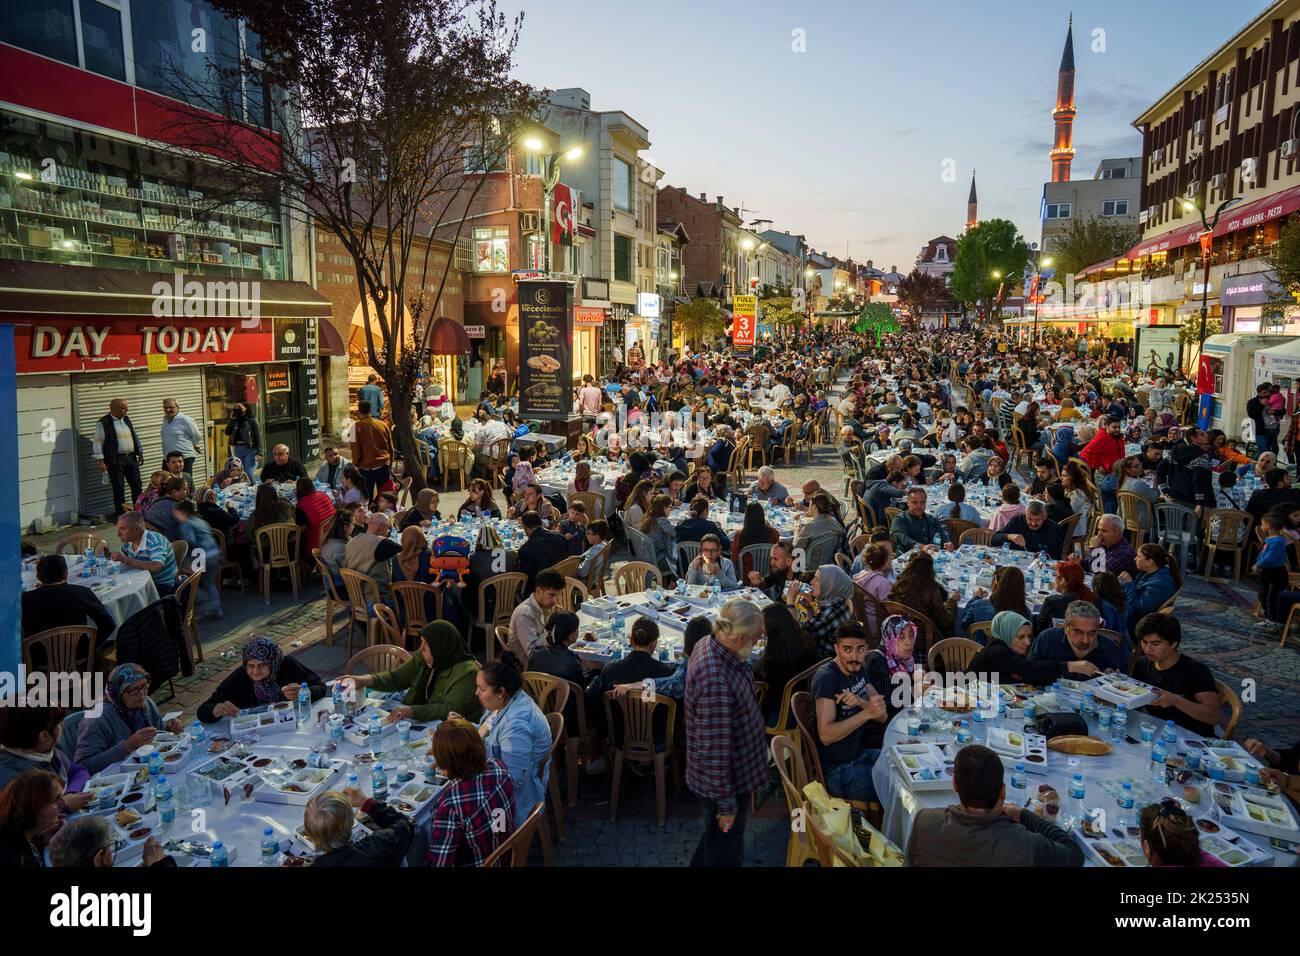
[0,259,332,319]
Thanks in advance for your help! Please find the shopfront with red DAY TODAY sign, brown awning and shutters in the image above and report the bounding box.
[0,261,329,527]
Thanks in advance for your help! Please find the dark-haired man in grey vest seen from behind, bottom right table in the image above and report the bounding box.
[907,744,1083,868]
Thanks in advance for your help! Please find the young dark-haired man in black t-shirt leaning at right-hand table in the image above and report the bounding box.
[1132,614,1219,736]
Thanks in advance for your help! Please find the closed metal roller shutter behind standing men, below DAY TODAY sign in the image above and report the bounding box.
[73,368,209,515]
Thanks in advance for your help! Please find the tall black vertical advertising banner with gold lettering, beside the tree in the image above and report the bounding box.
[519,282,573,421]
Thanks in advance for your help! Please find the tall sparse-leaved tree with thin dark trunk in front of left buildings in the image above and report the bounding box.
[154,0,543,490]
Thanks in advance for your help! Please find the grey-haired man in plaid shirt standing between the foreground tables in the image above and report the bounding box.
[685,598,768,866]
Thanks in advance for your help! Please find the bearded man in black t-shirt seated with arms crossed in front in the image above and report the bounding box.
[813,623,889,801]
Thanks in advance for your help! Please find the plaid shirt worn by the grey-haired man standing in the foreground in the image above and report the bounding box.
[685,637,768,814]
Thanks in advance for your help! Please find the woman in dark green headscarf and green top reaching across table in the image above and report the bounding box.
[345,620,482,723]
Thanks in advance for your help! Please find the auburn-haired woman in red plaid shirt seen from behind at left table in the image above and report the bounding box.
[425,718,512,866]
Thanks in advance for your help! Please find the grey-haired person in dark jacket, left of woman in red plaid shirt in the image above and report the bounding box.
[303,787,412,866]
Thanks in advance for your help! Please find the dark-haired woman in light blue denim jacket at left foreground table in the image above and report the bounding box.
[451,650,551,827]
